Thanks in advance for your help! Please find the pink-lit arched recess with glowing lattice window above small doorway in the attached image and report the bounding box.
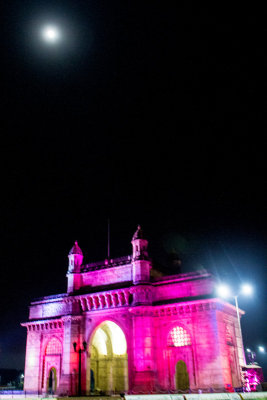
[167,326,195,391]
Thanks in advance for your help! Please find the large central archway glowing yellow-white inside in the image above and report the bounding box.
[88,321,128,393]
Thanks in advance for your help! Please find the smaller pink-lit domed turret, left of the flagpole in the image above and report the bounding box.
[67,241,83,293]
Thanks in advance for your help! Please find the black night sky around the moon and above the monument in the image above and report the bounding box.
[0,0,267,374]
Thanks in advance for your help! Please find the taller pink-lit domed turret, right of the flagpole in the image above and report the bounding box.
[132,225,151,284]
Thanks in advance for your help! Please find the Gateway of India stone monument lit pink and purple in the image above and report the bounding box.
[22,226,244,395]
